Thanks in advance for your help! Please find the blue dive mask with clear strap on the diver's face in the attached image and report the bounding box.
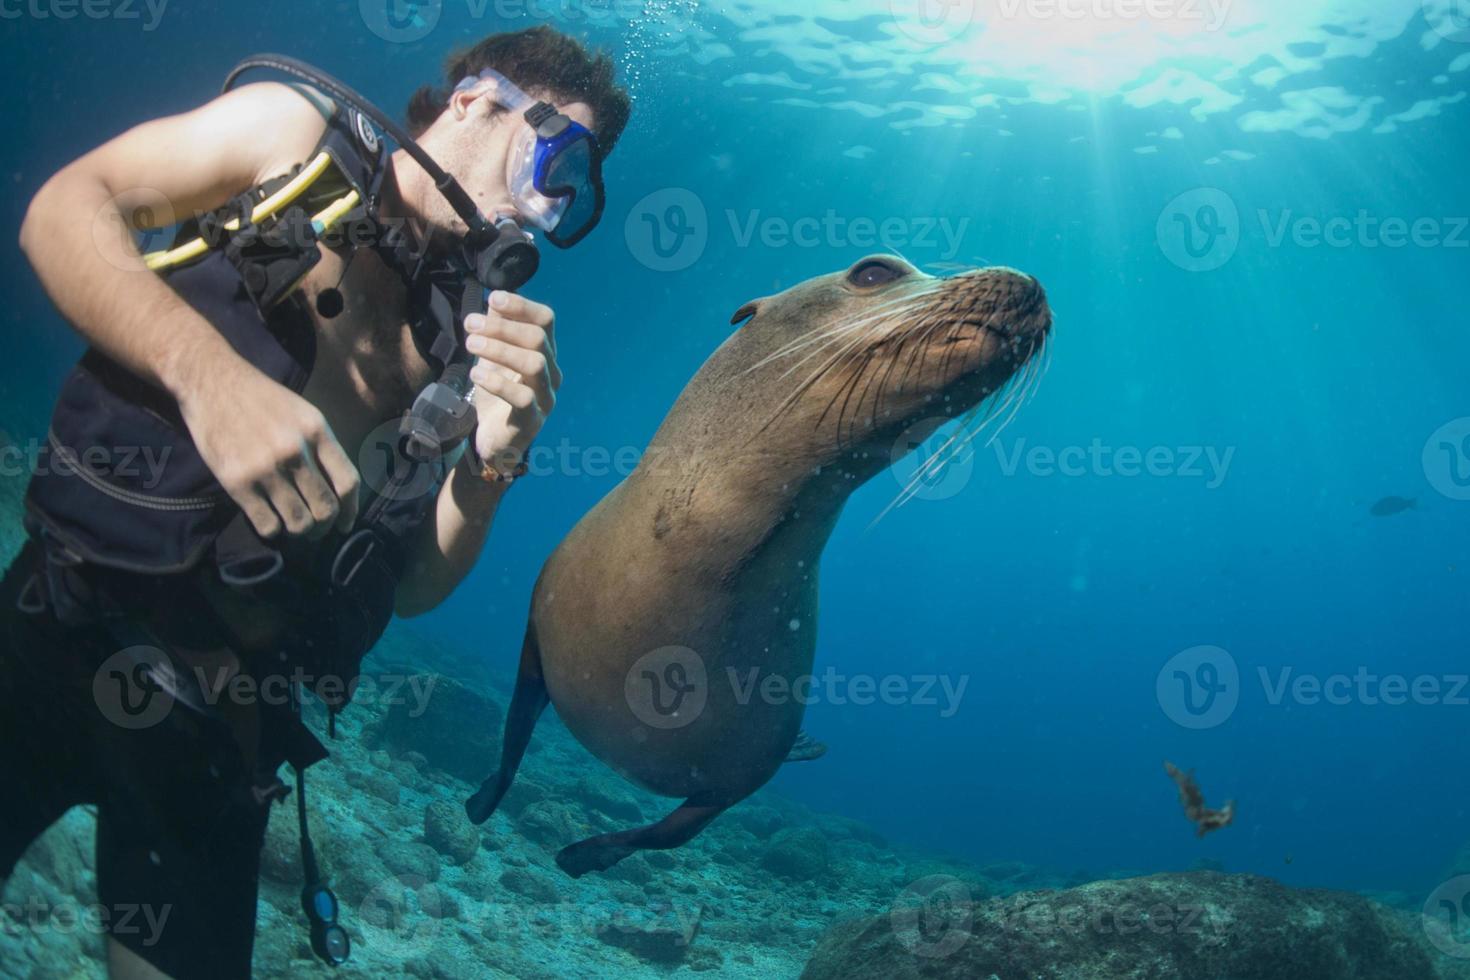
[454,69,607,248]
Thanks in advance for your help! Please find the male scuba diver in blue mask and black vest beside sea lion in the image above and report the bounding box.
[0,26,631,980]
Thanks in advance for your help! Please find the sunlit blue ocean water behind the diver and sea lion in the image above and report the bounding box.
[0,0,1470,910]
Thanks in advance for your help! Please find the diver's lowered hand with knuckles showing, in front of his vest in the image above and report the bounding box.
[179,360,359,538]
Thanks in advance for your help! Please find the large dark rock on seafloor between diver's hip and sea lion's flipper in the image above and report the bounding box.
[376,674,504,785]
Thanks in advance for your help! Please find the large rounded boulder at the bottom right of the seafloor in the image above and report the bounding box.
[801,871,1438,980]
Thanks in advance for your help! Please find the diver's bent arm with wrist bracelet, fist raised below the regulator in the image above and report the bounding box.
[397,292,562,616]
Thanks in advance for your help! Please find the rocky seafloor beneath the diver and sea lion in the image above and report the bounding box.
[0,449,1470,980]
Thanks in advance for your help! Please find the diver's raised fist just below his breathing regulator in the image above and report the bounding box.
[465,291,562,472]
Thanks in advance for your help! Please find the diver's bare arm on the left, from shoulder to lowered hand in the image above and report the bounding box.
[21,84,357,535]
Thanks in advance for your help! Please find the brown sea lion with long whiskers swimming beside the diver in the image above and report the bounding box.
[466,256,1051,877]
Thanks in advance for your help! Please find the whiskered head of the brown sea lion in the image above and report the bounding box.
[706,254,1053,478]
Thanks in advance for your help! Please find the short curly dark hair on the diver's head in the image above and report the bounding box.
[409,25,632,154]
